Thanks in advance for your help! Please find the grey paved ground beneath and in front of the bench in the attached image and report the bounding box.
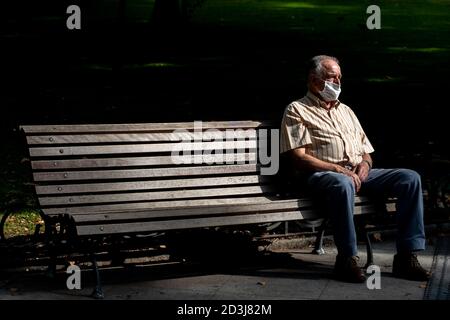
[0,236,435,301]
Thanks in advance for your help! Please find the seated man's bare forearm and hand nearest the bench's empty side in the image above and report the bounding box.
[290,148,364,192]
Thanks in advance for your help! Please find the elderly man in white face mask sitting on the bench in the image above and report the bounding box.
[280,55,430,282]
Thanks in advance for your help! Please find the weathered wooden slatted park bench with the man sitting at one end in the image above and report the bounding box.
[21,121,393,298]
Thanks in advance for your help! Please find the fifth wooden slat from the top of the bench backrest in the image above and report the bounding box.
[33,164,258,182]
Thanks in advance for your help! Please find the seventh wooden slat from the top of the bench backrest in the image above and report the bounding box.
[39,185,274,206]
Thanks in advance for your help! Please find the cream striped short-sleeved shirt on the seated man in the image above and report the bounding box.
[280,92,374,166]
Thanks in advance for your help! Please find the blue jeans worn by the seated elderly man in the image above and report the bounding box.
[307,169,425,256]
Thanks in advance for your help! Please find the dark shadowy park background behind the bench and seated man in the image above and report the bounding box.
[0,0,450,208]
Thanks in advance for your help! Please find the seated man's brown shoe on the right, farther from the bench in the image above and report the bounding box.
[392,253,431,281]
